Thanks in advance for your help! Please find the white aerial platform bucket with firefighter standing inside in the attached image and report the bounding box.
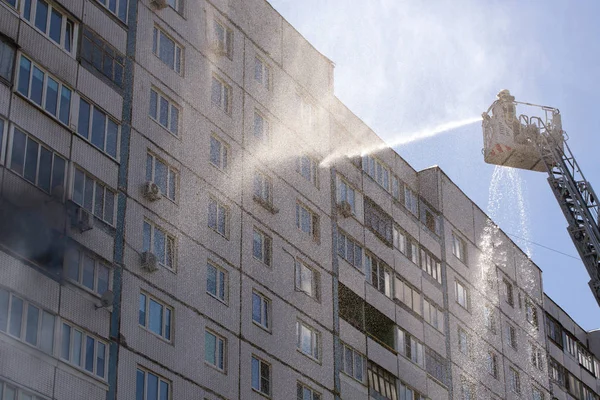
[482,90,564,172]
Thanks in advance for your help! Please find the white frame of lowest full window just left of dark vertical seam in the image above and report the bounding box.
[59,320,109,380]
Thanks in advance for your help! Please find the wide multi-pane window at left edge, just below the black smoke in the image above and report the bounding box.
[0,288,56,354]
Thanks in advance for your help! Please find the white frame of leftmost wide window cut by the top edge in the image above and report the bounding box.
[17,0,79,57]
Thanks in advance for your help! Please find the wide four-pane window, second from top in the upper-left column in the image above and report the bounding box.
[17,54,73,126]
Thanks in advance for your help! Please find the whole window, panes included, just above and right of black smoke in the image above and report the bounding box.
[71,167,117,225]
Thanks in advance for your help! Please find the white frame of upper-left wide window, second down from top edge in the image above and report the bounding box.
[13,53,75,125]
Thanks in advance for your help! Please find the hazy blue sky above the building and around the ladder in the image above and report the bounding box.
[270,0,600,330]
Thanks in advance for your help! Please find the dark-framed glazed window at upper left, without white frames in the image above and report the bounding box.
[79,27,125,88]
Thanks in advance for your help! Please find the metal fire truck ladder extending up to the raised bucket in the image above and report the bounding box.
[519,103,600,305]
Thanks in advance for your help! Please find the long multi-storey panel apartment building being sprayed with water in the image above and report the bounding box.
[0,0,600,400]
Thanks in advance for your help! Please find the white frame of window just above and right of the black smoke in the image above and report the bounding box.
[70,164,117,226]
